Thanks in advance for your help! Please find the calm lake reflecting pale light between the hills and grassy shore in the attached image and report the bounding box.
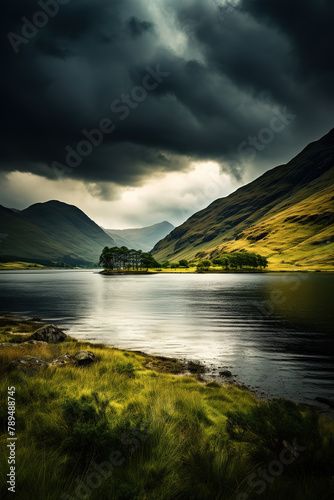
[0,270,334,403]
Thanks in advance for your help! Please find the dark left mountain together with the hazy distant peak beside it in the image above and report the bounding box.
[0,200,174,266]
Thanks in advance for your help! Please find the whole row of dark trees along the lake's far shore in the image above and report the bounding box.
[99,246,268,272]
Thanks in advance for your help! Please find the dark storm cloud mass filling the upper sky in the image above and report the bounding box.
[0,0,334,191]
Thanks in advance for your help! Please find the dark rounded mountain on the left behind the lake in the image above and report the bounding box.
[0,201,115,265]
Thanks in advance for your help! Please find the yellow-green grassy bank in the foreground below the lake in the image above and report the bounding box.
[0,321,334,500]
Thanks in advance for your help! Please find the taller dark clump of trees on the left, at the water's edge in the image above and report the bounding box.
[99,247,161,271]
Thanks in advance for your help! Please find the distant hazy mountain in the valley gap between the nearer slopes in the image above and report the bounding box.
[104,221,174,252]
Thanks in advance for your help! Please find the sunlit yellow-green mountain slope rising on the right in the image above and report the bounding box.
[152,129,334,270]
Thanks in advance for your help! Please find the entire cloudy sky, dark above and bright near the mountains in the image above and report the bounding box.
[0,0,334,228]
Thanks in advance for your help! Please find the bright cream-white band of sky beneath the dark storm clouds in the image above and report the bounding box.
[2,162,239,228]
